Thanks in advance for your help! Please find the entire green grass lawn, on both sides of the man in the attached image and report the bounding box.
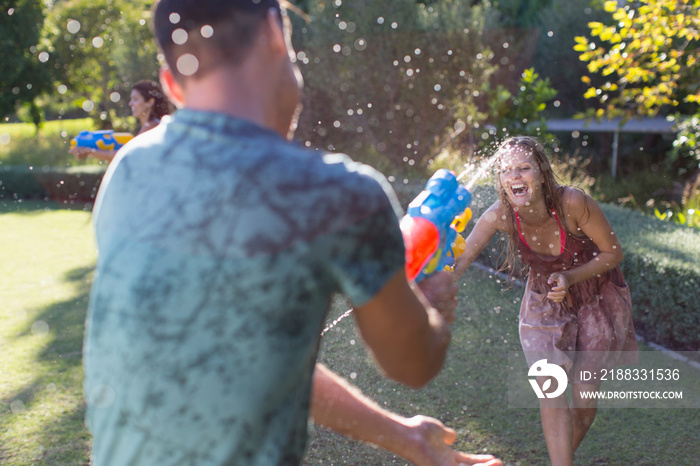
[0,201,700,466]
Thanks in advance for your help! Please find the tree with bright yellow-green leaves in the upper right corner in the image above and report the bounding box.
[574,0,700,169]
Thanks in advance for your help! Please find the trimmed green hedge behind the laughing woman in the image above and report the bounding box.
[466,187,700,351]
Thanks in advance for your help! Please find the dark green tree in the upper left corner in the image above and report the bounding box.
[0,0,51,129]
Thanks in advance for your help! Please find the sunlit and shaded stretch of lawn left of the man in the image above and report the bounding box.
[0,201,95,465]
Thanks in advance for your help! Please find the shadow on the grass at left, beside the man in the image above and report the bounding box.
[0,267,93,466]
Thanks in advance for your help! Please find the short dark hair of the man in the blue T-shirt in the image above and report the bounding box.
[153,0,281,77]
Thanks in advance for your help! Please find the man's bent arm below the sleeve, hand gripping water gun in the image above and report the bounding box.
[354,270,458,388]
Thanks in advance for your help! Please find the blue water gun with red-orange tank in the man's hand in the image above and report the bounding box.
[401,169,472,281]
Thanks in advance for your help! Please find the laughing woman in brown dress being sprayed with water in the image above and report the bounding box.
[455,136,637,466]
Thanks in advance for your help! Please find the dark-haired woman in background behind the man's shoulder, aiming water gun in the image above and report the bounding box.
[69,80,172,162]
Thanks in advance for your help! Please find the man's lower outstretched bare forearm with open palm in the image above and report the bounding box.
[311,364,502,466]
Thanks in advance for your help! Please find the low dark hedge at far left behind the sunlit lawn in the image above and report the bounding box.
[0,165,106,202]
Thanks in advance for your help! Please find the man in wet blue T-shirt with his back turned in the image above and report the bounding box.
[84,0,500,466]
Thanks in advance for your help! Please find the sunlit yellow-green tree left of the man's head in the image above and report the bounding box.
[44,0,158,127]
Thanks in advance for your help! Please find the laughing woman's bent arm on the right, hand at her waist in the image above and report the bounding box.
[548,189,623,302]
